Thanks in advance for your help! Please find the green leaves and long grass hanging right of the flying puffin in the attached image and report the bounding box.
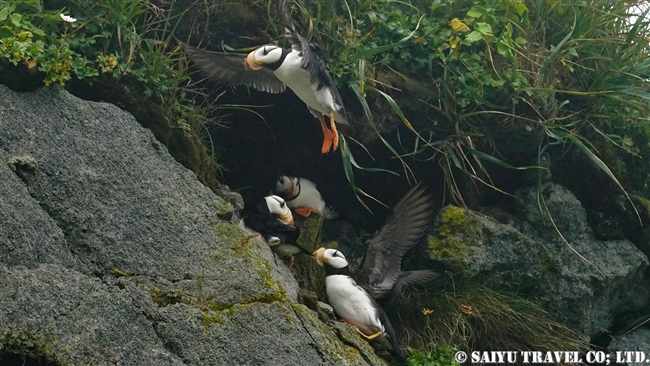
[280,0,650,209]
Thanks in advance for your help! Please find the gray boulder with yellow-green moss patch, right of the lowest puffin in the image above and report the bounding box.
[428,183,650,339]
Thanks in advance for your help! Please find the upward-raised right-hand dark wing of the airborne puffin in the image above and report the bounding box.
[278,0,336,93]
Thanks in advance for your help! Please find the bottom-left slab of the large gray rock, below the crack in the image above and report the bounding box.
[0,264,183,366]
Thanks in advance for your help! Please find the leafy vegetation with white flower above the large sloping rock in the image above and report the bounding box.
[0,0,218,187]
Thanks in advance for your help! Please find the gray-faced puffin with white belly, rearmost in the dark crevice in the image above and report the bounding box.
[273,175,337,219]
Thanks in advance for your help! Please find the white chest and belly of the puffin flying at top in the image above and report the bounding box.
[274,51,336,114]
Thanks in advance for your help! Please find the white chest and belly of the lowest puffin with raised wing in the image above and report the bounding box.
[325,275,385,335]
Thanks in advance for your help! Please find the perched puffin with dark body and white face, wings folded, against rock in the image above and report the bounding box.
[239,196,311,267]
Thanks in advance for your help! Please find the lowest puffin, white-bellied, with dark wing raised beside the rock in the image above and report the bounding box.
[313,184,438,357]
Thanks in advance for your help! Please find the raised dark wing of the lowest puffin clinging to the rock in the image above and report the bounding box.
[355,184,433,299]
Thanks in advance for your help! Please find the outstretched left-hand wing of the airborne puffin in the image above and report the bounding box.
[181,43,287,94]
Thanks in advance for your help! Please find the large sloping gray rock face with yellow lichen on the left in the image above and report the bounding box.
[0,85,383,365]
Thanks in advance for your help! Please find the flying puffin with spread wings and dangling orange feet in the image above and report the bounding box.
[183,0,348,154]
